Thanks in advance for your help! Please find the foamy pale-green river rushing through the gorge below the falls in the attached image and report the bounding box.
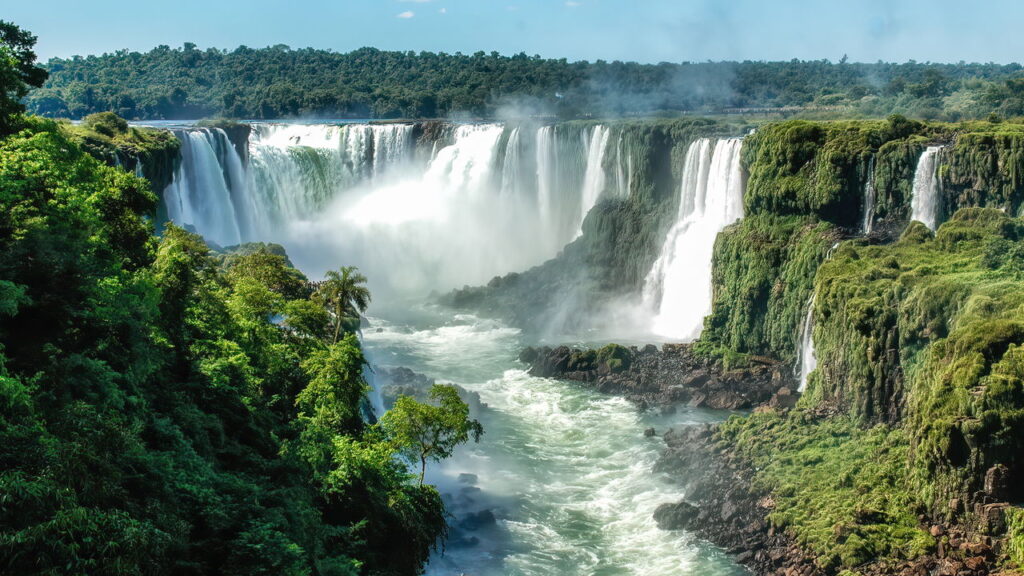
[366,307,742,576]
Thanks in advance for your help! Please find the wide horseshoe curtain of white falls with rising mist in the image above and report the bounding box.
[164,123,621,294]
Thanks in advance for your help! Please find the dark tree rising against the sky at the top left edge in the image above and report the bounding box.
[0,20,47,135]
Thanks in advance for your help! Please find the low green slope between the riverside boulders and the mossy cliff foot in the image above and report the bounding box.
[719,412,934,569]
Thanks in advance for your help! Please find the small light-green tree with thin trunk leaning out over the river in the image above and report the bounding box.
[381,384,483,486]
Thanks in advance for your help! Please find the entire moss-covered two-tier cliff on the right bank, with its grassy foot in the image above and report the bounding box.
[698,122,1024,573]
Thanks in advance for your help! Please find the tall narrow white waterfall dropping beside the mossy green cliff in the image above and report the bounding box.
[643,138,743,340]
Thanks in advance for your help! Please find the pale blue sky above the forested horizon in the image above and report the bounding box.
[8,0,1024,63]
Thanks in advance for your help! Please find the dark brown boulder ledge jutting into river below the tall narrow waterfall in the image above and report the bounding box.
[519,344,798,410]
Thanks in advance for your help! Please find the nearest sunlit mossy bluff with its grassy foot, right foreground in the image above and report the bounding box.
[719,208,1024,568]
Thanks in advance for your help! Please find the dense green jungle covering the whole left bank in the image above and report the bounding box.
[0,23,479,576]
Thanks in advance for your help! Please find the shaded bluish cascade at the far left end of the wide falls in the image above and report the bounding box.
[164,128,244,246]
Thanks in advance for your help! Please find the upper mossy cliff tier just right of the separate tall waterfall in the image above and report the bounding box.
[702,118,1024,361]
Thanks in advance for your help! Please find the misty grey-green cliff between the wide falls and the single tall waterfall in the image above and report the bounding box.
[443,119,749,330]
